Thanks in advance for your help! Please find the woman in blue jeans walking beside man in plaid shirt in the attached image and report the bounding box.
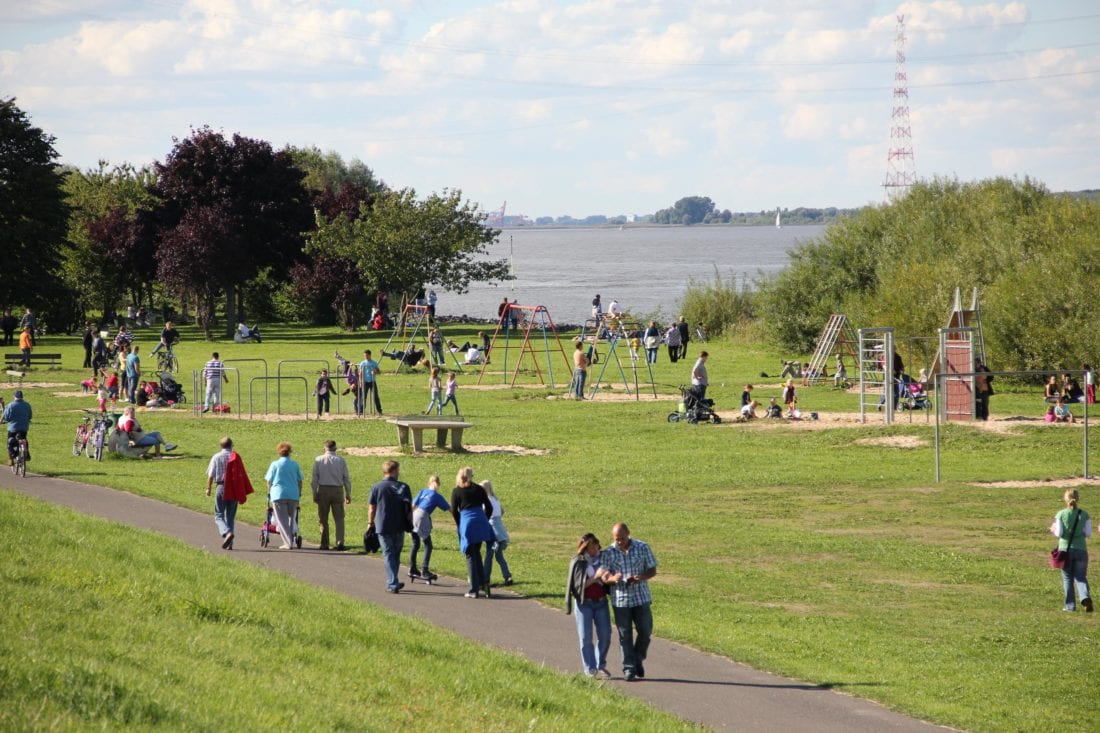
[565,532,612,679]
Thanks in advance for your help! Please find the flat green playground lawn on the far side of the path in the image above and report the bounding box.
[2,327,1100,731]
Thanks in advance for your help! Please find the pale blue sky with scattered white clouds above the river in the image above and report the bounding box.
[0,0,1100,218]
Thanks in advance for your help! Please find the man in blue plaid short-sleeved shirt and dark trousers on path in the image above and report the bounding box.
[600,522,657,682]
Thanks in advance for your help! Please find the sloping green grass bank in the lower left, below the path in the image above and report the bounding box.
[0,491,690,731]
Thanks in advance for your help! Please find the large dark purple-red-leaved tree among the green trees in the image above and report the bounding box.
[153,128,314,336]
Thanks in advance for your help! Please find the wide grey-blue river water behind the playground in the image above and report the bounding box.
[437,227,825,324]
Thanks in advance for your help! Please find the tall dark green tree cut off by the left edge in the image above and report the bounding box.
[0,98,70,314]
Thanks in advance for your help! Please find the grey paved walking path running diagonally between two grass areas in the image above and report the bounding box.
[0,471,947,733]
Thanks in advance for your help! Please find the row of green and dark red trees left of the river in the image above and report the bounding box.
[0,99,509,338]
